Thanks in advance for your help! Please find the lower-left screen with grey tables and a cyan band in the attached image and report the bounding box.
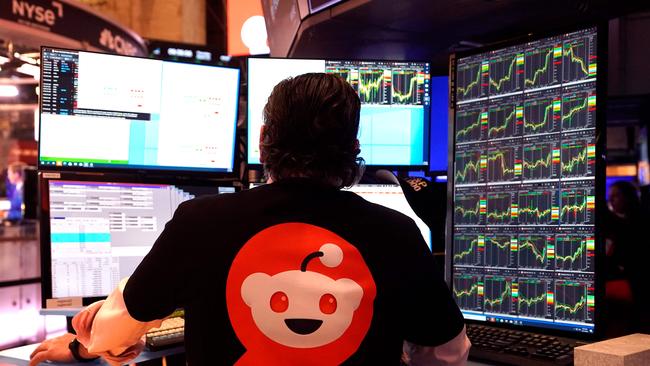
[41,179,234,307]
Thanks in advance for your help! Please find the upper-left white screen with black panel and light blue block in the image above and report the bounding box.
[39,48,239,173]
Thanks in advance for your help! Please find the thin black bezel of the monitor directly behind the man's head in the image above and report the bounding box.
[245,55,431,171]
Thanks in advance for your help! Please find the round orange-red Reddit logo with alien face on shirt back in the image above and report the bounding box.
[226,223,376,365]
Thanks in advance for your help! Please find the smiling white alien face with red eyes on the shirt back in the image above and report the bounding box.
[241,244,363,348]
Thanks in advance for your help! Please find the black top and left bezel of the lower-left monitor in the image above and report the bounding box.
[38,171,241,309]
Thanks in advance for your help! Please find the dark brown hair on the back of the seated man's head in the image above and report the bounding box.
[260,73,363,188]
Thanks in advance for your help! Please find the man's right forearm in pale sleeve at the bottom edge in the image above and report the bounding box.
[403,328,471,366]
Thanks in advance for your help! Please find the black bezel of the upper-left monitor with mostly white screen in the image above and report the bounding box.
[37,45,242,179]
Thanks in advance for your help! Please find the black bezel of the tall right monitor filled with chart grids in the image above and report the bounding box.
[445,21,608,341]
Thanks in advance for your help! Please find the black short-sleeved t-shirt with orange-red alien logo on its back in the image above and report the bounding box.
[124,179,463,365]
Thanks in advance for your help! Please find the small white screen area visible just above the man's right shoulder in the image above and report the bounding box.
[347,184,431,249]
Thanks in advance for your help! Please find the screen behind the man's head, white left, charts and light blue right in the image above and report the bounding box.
[248,58,430,167]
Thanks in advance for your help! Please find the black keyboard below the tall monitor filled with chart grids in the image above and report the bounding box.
[467,324,586,366]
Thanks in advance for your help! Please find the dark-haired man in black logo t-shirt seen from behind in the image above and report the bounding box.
[32,74,469,365]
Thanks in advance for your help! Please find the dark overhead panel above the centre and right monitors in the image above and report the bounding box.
[286,0,650,74]
